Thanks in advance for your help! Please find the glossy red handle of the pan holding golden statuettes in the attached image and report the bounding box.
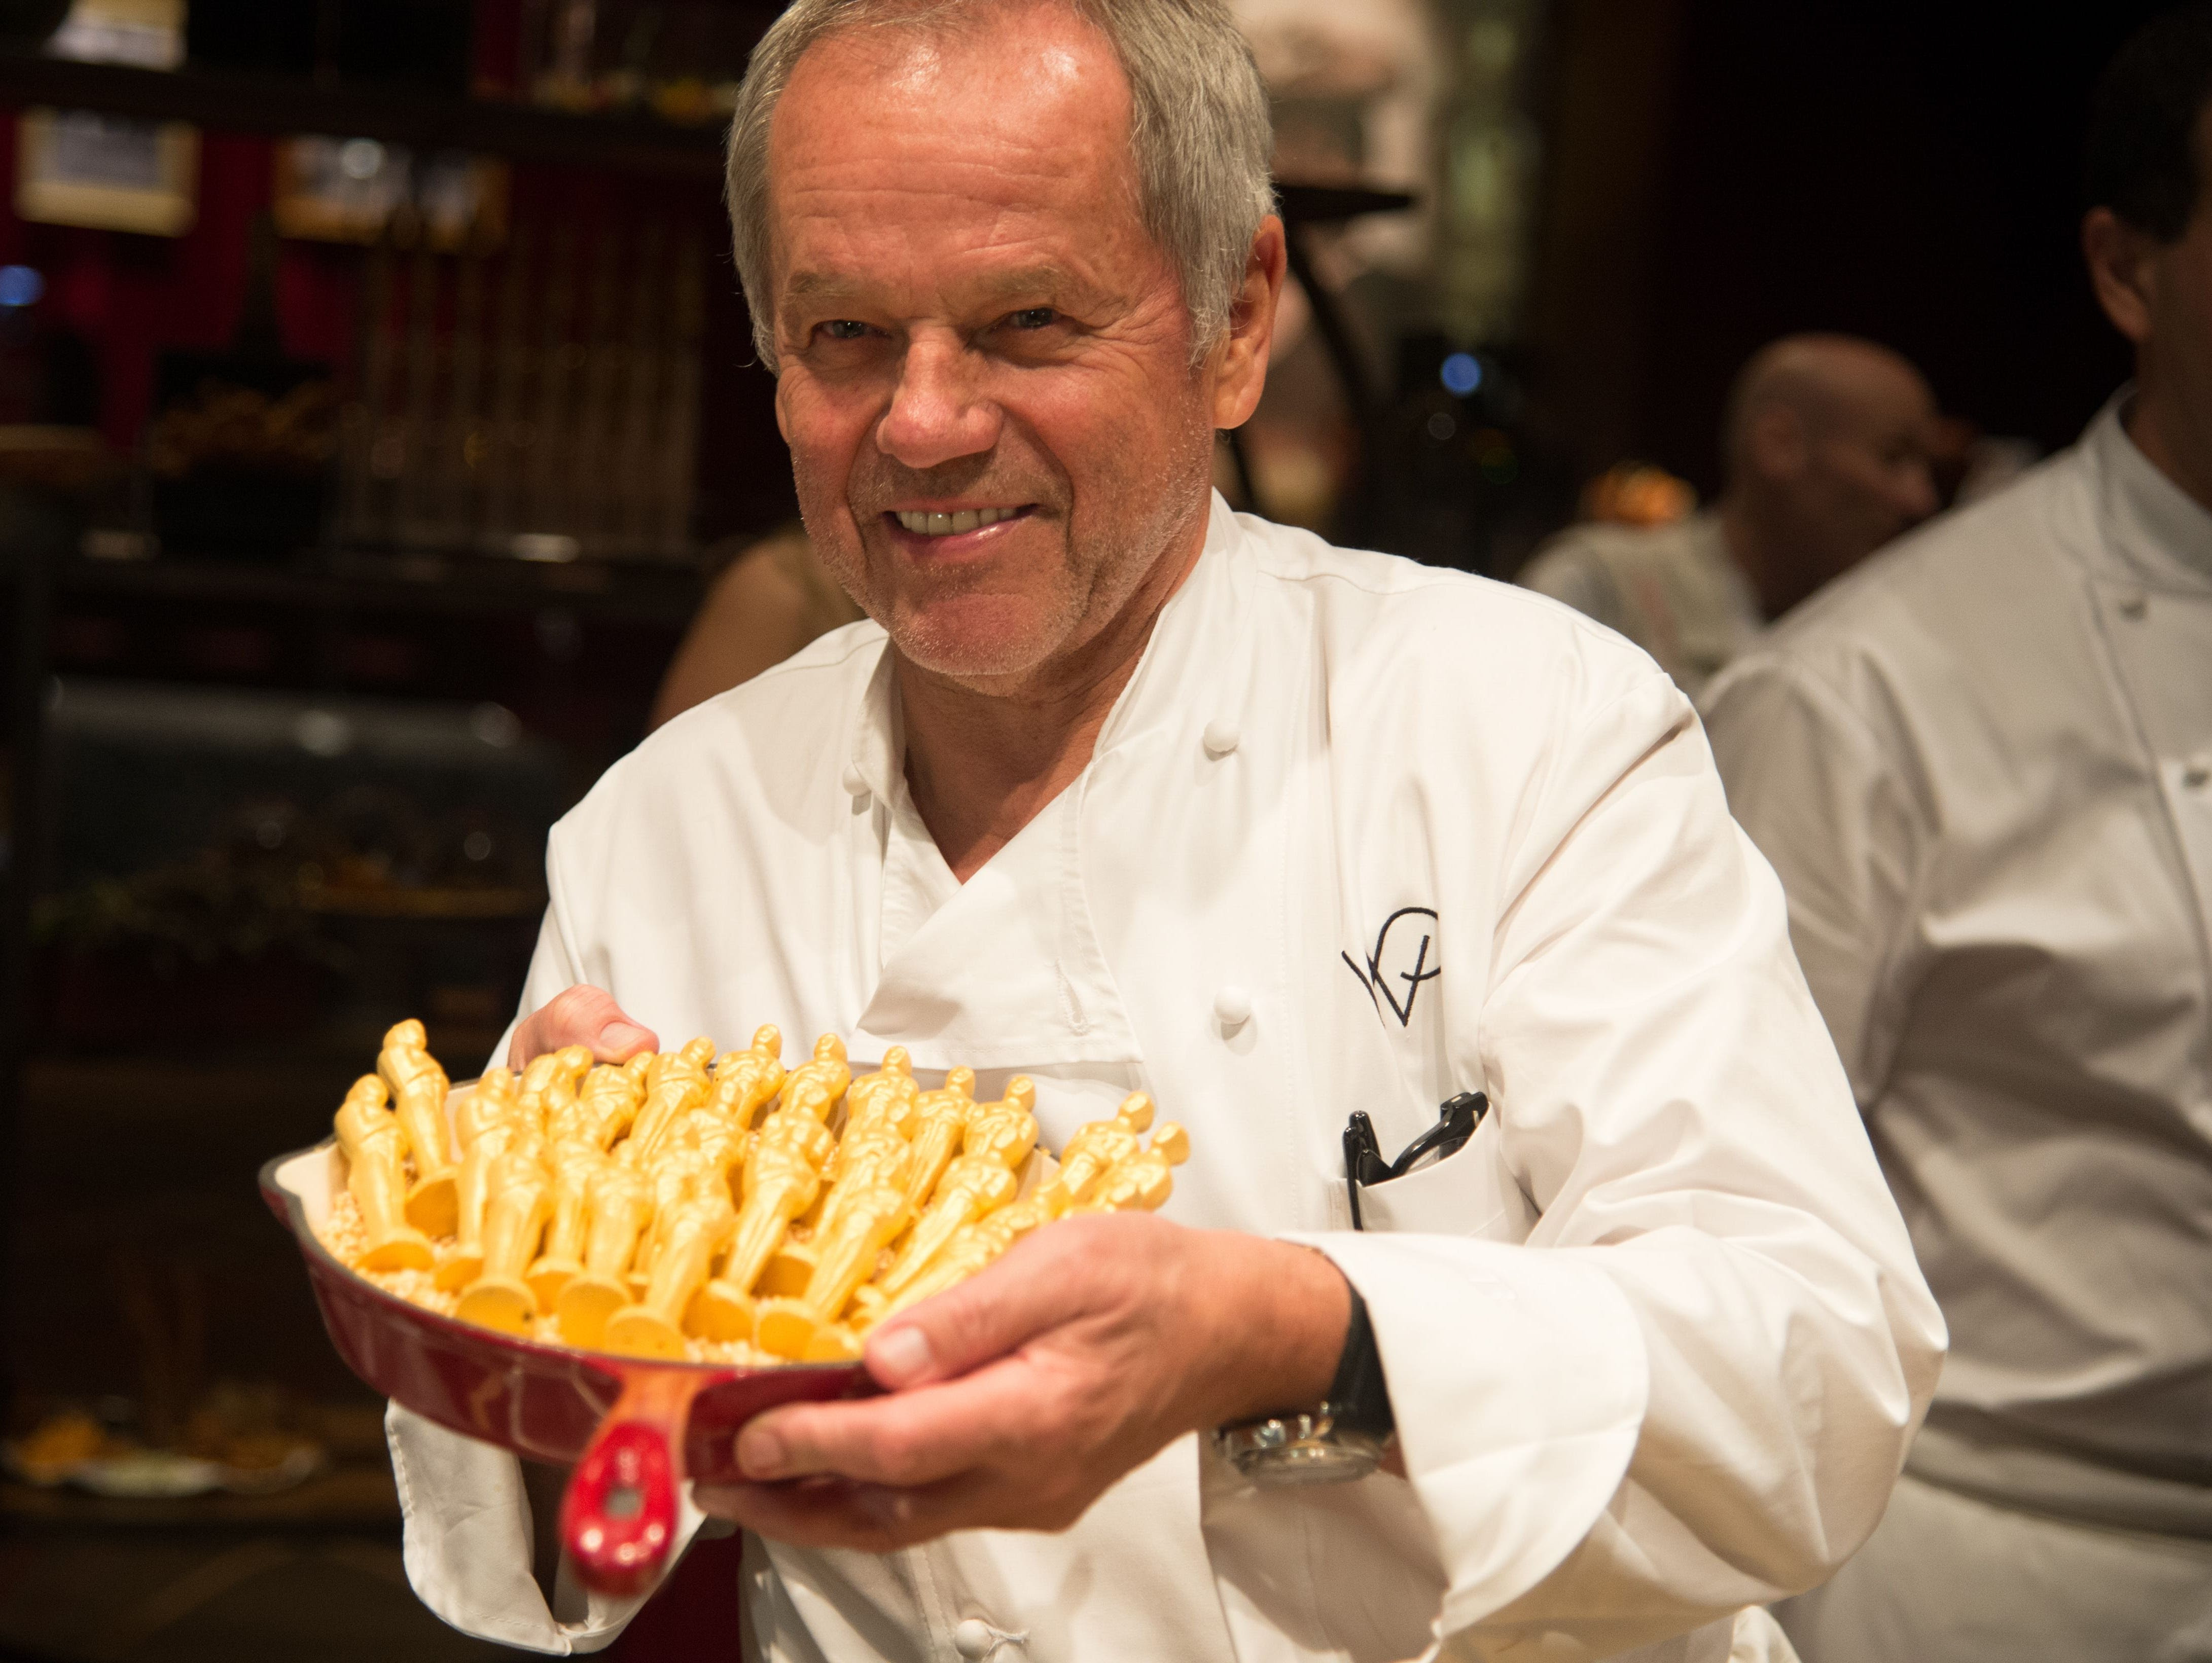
[560,1367,712,1595]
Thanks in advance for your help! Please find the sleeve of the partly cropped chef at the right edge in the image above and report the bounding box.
[1705,655,1929,1112]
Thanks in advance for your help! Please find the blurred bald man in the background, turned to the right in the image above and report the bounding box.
[1520,334,1936,697]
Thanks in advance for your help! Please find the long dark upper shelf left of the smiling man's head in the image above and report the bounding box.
[0,51,721,184]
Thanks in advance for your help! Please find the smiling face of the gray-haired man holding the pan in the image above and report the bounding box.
[768,5,1212,681]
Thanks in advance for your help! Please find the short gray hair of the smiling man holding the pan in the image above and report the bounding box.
[723,0,1274,369]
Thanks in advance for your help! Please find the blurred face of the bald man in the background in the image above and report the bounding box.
[1794,367,1936,593]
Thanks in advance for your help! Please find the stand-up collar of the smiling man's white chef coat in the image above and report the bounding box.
[849,491,1250,803]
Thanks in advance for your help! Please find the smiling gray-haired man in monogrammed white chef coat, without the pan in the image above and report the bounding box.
[391,0,1942,1663]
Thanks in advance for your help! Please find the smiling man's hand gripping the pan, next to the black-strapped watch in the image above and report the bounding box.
[697,1214,1351,1552]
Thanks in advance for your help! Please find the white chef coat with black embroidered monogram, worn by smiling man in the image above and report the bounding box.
[394,497,1942,1663]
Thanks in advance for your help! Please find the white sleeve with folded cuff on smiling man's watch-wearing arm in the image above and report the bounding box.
[1309,670,1942,1658]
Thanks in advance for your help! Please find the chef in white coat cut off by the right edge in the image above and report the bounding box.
[1707,5,2212,1663]
